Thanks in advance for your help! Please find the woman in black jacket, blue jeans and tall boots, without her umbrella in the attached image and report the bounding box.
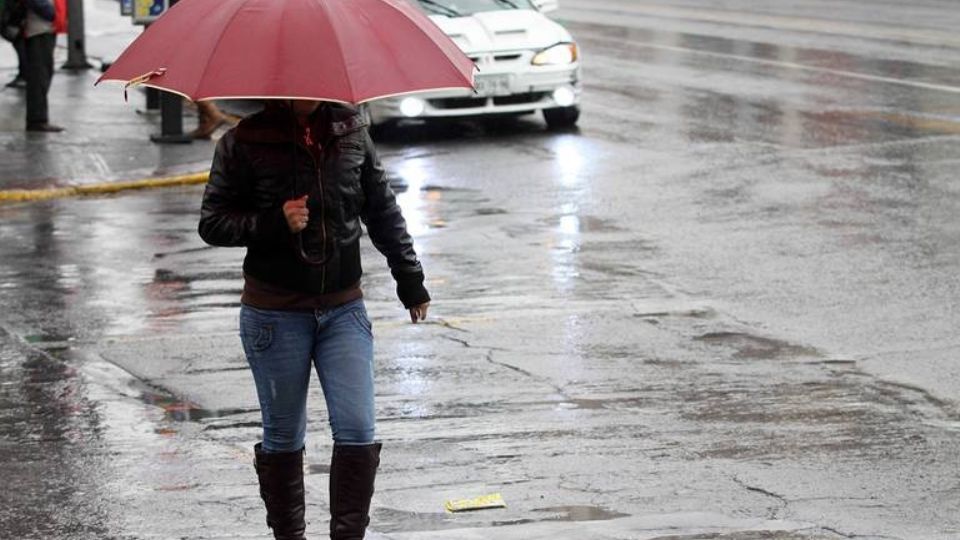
[199,100,430,540]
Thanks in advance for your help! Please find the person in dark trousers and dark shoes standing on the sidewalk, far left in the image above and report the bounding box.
[23,0,63,133]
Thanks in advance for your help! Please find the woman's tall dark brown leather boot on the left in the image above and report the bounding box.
[253,444,307,540]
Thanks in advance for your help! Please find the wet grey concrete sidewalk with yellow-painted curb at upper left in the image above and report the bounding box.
[0,0,214,190]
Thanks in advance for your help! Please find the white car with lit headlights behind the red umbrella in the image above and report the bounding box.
[367,0,580,128]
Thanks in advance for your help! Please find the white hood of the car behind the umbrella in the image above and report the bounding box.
[430,9,572,54]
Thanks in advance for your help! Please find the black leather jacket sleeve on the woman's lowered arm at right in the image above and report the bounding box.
[360,131,430,309]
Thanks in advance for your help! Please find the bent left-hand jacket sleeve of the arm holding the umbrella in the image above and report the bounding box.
[199,132,290,247]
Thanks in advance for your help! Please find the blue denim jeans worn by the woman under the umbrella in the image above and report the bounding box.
[240,299,375,452]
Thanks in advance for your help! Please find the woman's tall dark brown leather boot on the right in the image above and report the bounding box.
[330,443,381,540]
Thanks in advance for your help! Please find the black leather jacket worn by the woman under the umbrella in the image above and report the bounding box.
[199,104,430,308]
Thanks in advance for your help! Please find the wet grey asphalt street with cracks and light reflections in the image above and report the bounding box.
[0,0,960,540]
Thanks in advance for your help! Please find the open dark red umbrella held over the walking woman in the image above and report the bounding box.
[97,0,475,103]
